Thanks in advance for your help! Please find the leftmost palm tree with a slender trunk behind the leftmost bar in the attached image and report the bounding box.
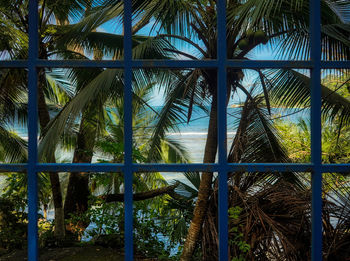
[0,1,75,236]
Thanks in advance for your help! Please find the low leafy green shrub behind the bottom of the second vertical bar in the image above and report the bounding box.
[68,197,178,260]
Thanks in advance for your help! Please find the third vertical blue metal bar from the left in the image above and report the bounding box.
[217,0,228,261]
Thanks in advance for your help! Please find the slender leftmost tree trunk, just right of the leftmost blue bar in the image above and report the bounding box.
[38,70,65,238]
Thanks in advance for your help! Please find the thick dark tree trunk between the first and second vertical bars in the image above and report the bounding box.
[64,112,96,223]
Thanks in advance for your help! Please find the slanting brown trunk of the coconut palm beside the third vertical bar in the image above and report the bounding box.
[180,92,218,261]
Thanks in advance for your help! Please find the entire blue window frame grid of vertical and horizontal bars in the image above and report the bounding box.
[0,0,350,261]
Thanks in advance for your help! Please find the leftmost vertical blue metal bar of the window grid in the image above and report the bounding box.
[27,0,38,261]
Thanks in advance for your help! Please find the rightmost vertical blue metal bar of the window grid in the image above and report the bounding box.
[310,0,322,261]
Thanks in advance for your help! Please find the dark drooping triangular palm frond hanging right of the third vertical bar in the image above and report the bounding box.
[228,93,303,191]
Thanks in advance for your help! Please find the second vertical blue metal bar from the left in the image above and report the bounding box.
[124,0,133,261]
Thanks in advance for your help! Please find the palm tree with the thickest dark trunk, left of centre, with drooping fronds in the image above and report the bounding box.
[35,1,193,226]
